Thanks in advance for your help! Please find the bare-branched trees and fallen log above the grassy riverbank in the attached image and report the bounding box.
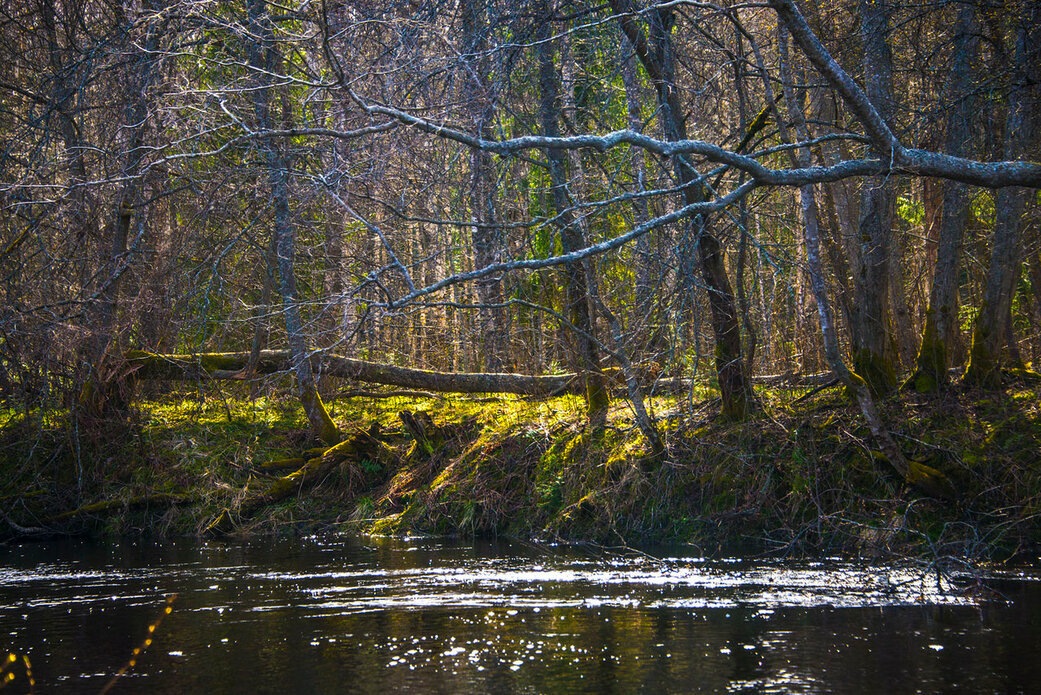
[0,0,1041,472]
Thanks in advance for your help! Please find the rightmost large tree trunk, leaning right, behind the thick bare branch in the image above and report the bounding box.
[965,3,1041,388]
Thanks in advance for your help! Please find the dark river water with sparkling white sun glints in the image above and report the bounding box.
[0,539,1041,694]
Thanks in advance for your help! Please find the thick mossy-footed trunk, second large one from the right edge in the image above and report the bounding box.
[908,4,977,392]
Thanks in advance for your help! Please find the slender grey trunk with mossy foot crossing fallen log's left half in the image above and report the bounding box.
[249,0,340,444]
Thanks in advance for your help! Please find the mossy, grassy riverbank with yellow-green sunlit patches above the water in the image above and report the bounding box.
[0,386,1041,558]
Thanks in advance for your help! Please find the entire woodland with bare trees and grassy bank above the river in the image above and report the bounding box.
[0,0,1041,551]
